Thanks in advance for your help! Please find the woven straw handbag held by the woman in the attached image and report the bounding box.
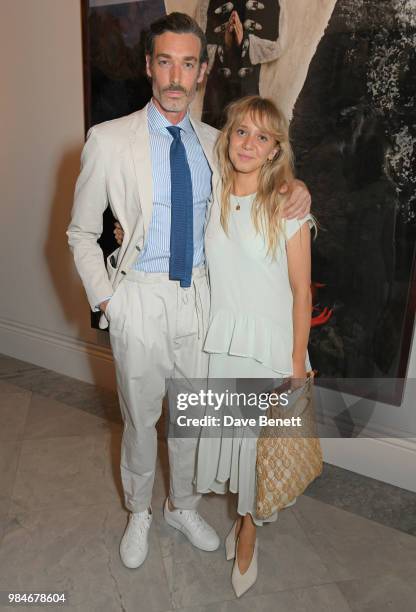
[256,372,323,519]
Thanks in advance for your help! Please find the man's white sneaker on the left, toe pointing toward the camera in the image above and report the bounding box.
[120,510,153,569]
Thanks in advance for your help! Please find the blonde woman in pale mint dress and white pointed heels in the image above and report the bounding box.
[196,96,314,596]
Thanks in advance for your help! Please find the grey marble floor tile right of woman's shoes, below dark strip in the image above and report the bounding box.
[293,495,416,581]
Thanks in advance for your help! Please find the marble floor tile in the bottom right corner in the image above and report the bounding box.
[337,564,416,612]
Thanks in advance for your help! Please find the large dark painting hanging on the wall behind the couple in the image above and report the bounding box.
[83,0,416,403]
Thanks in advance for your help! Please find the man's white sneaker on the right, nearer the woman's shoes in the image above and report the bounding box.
[163,500,220,551]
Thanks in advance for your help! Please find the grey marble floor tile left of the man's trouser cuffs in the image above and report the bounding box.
[12,434,122,511]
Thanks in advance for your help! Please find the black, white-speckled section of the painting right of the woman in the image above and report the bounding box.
[291,0,416,403]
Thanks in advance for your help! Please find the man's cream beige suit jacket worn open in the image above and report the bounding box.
[67,106,219,329]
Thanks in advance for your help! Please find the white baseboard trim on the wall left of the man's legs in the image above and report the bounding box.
[0,318,116,389]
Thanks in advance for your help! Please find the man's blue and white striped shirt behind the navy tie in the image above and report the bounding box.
[133,101,212,272]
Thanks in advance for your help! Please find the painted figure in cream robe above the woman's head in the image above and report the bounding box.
[193,0,336,127]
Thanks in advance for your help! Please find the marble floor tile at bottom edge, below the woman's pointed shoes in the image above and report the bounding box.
[176,584,351,612]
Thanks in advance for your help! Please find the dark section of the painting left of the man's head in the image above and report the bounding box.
[83,0,165,129]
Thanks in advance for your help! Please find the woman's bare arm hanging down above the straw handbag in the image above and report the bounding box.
[286,222,312,378]
